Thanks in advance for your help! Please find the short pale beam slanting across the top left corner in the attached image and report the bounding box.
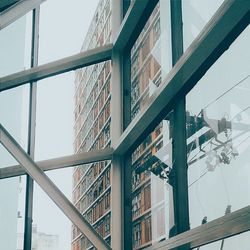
[0,0,45,30]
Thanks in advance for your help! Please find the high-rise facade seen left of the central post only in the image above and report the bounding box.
[72,0,111,250]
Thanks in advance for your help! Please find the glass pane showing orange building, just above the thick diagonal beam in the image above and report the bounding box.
[131,0,172,119]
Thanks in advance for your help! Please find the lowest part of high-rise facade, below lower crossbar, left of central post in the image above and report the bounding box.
[72,161,111,249]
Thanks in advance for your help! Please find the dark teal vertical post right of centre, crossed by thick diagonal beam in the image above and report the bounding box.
[170,0,189,247]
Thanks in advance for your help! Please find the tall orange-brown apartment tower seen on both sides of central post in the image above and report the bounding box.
[72,0,166,250]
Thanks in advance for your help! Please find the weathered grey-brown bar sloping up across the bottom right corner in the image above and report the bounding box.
[147,206,250,250]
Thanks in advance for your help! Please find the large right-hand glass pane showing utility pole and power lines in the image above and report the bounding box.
[187,25,250,228]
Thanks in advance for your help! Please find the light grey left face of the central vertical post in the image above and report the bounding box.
[111,0,123,249]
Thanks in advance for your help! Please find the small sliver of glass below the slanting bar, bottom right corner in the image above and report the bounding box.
[194,232,250,250]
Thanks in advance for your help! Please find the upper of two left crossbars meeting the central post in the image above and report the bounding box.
[0,44,113,92]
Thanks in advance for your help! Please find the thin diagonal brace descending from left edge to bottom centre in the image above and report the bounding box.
[0,124,111,249]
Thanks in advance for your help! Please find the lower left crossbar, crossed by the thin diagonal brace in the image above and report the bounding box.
[0,148,114,179]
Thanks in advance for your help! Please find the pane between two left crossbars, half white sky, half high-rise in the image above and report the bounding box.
[36,61,111,160]
